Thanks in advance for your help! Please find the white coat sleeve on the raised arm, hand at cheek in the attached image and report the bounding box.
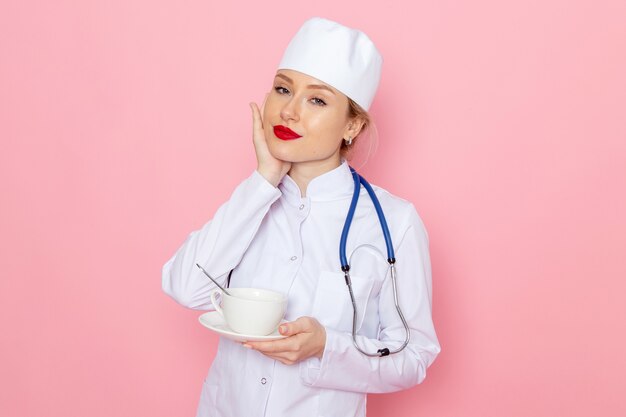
[161,170,281,310]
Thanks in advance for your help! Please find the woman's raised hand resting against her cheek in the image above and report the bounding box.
[250,94,291,187]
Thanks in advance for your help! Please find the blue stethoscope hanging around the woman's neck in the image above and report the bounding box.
[339,167,411,357]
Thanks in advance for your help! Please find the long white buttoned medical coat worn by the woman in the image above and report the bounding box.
[162,162,440,417]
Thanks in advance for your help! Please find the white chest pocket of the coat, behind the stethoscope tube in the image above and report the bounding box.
[313,271,374,333]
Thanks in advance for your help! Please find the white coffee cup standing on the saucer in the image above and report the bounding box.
[211,288,287,336]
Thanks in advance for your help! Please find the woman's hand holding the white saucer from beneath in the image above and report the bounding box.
[243,317,326,365]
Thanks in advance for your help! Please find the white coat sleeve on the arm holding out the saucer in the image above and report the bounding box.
[300,205,441,393]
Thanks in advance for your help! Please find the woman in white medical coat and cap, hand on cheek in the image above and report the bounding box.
[162,18,440,417]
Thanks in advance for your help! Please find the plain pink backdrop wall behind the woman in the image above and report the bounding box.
[0,0,626,417]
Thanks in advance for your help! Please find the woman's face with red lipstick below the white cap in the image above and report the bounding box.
[263,69,358,166]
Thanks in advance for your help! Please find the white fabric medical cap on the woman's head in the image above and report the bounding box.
[278,17,383,110]
